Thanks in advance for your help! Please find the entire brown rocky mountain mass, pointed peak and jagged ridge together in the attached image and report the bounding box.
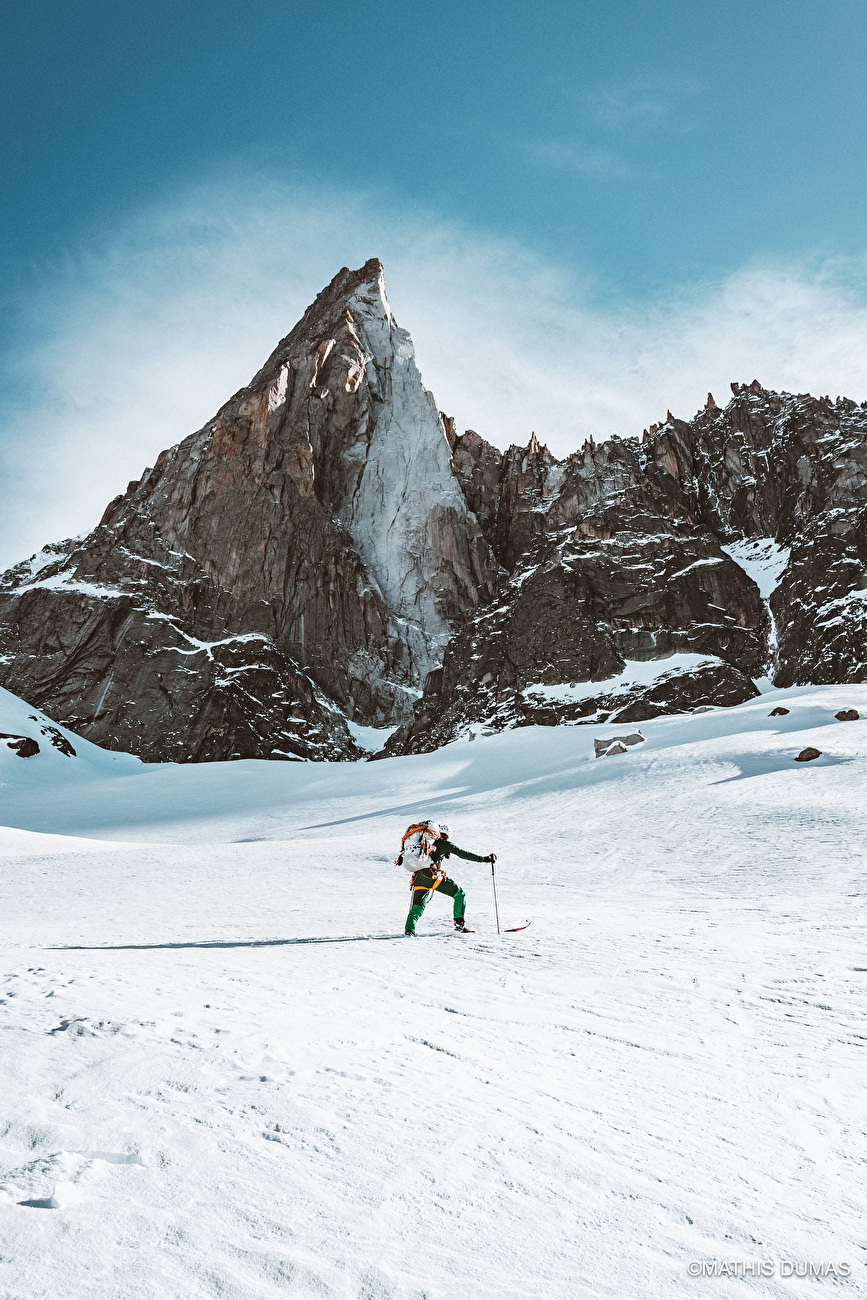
[0,260,867,762]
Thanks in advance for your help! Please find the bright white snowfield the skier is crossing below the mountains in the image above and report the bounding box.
[0,686,867,1300]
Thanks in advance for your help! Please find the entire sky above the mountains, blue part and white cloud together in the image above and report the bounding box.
[0,0,867,558]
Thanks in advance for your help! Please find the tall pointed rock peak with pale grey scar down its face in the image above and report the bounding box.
[0,260,495,761]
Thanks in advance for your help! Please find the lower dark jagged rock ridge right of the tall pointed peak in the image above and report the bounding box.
[387,382,867,753]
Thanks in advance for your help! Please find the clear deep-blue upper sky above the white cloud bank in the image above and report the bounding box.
[0,0,867,293]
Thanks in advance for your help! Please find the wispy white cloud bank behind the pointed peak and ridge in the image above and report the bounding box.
[0,176,867,566]
